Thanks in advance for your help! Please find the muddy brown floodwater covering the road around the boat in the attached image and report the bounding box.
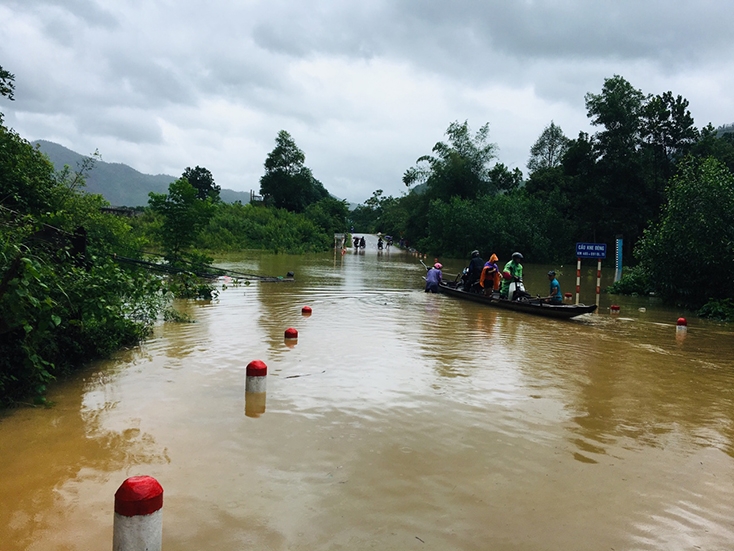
[0,247,734,551]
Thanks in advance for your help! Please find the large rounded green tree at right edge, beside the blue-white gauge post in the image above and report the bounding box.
[635,157,734,307]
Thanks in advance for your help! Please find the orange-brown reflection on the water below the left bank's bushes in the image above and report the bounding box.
[0,351,170,549]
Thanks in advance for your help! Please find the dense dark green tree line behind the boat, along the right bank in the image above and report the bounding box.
[352,75,734,313]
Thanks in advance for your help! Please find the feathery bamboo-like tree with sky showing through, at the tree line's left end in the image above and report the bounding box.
[403,121,498,200]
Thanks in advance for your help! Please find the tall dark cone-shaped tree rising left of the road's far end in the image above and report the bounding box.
[260,130,329,212]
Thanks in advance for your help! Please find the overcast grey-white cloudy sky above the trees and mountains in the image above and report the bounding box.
[0,0,734,202]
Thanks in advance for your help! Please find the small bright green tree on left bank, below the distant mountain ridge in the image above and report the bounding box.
[148,178,213,263]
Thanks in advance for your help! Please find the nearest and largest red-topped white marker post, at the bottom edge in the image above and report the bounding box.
[112,476,163,551]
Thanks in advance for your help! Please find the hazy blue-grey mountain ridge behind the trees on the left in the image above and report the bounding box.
[33,140,250,207]
